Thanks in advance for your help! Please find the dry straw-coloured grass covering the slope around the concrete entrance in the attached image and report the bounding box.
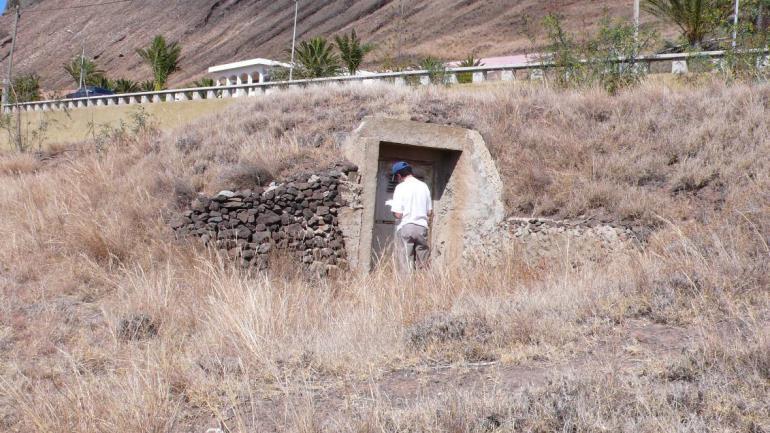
[0,79,770,432]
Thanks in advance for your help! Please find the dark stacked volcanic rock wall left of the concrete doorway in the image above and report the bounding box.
[170,164,358,272]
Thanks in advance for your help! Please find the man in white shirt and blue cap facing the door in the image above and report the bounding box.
[389,161,433,273]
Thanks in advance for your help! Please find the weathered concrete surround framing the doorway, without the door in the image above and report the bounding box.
[340,117,504,272]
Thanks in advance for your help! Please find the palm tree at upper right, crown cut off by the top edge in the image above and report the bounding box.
[642,0,731,47]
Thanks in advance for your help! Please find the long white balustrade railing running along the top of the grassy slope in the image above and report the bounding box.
[3,51,770,112]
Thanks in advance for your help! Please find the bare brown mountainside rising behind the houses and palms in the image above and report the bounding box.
[0,0,656,89]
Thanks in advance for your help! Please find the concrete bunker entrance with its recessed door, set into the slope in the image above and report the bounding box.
[340,117,504,272]
